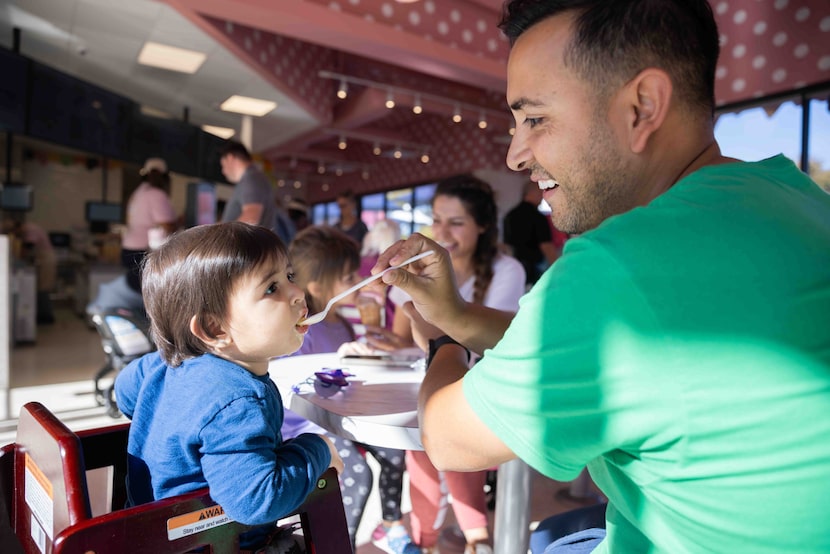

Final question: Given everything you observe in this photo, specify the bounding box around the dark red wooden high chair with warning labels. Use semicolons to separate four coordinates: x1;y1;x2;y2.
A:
0;402;351;554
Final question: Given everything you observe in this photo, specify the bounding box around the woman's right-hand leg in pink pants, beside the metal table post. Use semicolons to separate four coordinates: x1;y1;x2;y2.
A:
444;471;490;545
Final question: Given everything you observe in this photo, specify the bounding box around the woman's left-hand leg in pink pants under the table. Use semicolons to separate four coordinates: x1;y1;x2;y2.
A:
406;451;448;548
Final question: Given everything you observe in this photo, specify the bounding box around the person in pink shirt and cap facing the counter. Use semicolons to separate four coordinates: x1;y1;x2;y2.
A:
121;158;178;292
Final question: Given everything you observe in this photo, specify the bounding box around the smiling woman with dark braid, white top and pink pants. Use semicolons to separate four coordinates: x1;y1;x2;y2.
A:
389;175;525;554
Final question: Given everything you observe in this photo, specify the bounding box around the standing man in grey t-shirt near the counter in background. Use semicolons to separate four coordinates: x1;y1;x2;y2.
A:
219;140;295;245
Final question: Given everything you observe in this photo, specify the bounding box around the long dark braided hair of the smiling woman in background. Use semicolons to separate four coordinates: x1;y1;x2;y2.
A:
432;175;499;304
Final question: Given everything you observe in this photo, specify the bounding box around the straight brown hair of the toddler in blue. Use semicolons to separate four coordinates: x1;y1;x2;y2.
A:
141;221;288;367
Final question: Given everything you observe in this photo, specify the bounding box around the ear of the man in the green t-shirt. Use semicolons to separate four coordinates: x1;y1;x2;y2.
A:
618;67;674;154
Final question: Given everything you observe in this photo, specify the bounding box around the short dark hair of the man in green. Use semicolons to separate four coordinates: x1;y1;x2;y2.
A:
499;0;720;114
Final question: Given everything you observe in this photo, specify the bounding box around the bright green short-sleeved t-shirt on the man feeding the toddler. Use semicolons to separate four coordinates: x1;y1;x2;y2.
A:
464;156;830;554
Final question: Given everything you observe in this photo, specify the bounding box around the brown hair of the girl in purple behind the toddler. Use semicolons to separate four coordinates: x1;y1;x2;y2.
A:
289;225;360;313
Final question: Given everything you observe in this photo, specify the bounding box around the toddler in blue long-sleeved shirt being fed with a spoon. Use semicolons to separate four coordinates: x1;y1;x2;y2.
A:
115;222;346;550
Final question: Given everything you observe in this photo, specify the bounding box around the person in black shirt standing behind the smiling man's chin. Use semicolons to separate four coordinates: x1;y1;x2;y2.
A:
504;181;560;285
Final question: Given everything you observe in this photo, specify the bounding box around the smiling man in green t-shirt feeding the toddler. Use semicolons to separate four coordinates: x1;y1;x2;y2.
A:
376;0;830;553
